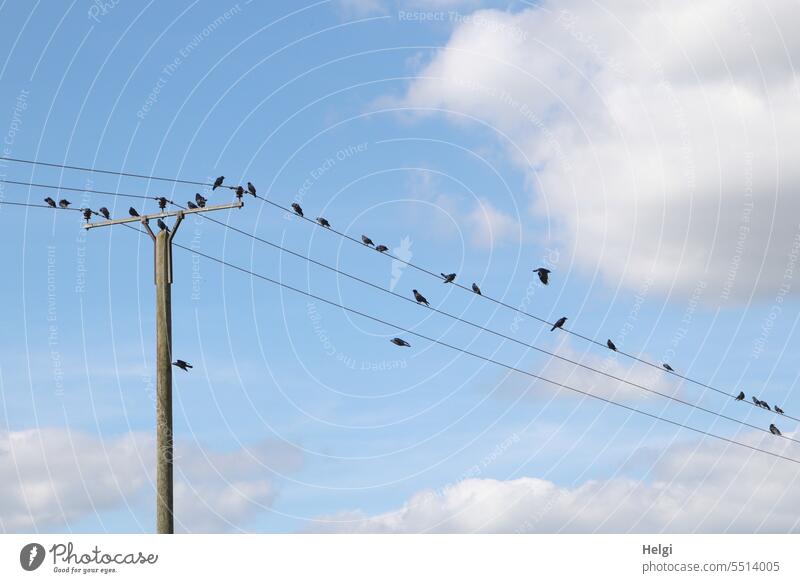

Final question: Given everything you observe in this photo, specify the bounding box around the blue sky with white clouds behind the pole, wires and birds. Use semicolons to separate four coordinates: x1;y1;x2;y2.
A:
0;0;800;533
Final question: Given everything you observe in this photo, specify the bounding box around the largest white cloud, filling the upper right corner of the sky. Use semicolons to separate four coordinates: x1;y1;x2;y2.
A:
403;0;800;300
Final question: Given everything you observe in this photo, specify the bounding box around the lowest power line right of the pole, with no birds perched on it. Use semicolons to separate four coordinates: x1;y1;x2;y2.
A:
173;243;800;464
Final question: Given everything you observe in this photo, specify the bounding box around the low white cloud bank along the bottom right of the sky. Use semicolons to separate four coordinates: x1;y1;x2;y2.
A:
315;436;800;533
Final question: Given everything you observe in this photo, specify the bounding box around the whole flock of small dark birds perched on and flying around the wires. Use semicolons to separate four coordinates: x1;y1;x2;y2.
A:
44;176;785;435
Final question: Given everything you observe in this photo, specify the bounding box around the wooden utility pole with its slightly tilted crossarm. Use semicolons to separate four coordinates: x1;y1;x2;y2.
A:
84;200;244;534
